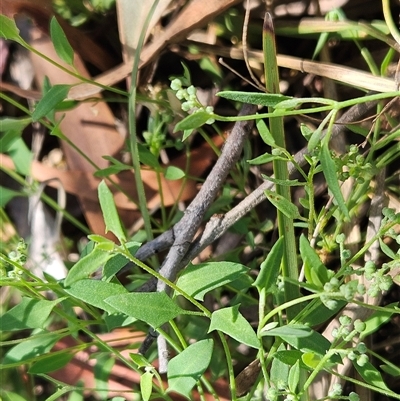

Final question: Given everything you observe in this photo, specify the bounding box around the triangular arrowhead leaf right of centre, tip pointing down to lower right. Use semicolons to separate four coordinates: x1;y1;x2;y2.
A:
208;305;260;349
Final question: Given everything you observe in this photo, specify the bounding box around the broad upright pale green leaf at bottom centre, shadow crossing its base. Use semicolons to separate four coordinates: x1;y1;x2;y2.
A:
168;339;214;399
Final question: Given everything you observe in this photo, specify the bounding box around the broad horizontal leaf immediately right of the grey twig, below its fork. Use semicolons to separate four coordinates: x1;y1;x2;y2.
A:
176;262;248;301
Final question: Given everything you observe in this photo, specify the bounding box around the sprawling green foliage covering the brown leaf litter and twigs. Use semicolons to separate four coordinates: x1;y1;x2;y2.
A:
0;0;400;401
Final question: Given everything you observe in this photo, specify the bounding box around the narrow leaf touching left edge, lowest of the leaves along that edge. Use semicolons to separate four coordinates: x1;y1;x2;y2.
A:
0;332;61;368
